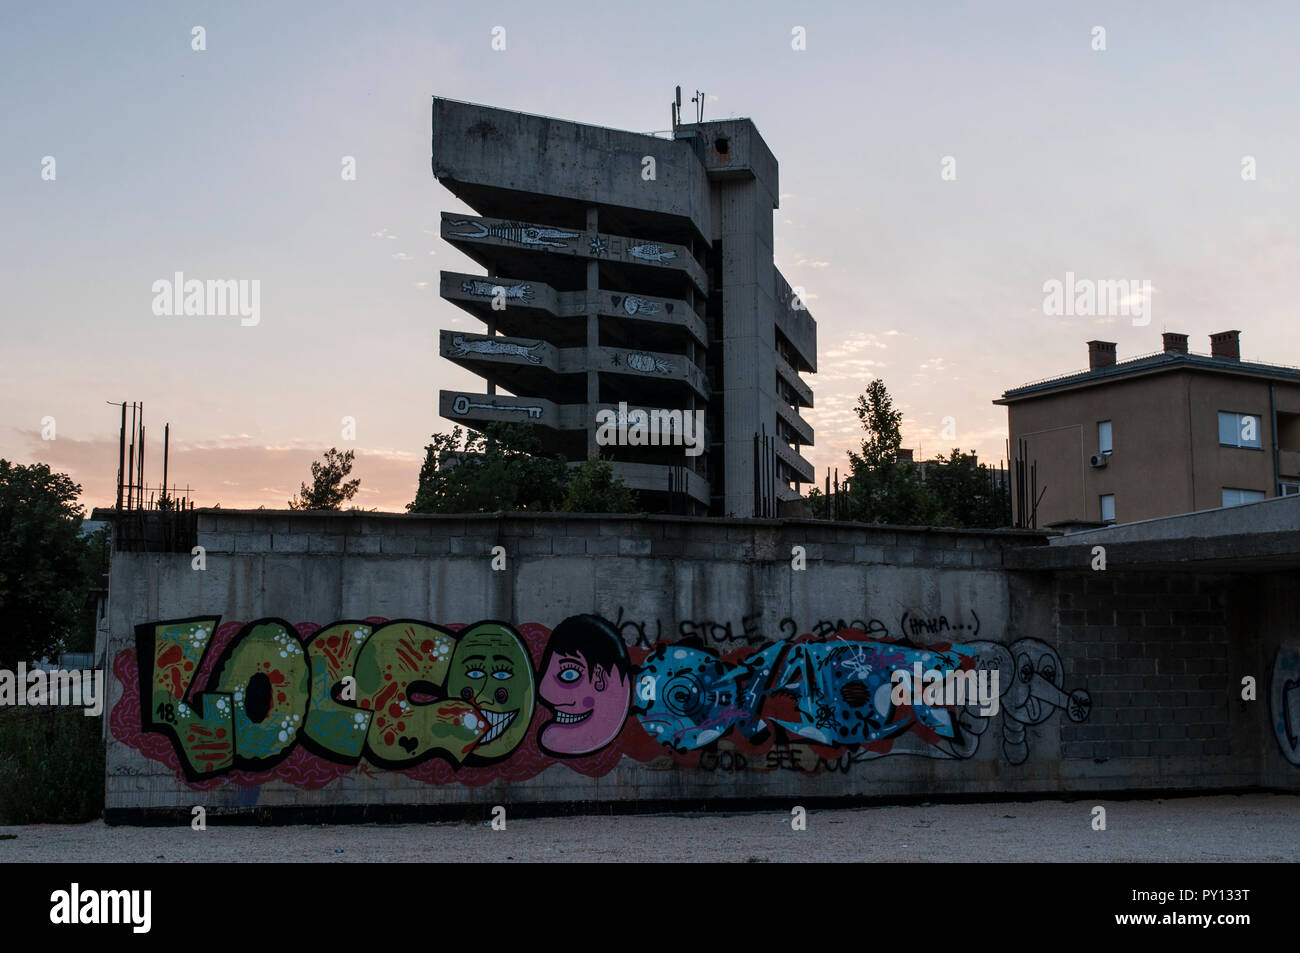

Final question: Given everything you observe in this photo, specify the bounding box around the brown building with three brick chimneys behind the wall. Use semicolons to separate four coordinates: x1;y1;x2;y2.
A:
993;330;1300;527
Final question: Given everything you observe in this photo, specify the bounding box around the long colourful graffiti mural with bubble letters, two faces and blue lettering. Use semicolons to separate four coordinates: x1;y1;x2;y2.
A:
111;611;1091;788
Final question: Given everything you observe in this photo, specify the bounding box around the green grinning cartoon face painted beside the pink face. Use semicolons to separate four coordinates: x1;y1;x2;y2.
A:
447;623;537;759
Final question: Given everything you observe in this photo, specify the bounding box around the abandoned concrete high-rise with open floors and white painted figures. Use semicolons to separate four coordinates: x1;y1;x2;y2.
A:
433;99;816;516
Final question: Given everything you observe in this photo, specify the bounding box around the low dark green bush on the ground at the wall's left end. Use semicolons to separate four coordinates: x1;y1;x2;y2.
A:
0;709;104;824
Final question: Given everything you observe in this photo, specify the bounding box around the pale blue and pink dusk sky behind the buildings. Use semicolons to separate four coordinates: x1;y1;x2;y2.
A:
0;0;1300;511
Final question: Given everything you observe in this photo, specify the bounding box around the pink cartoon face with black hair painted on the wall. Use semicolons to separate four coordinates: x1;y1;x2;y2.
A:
538;616;632;758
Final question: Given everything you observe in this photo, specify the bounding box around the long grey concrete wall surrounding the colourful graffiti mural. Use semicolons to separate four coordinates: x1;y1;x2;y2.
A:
104;511;1300;819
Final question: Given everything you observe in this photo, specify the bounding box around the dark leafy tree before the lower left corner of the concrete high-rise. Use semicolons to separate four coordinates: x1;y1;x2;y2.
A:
407;424;568;512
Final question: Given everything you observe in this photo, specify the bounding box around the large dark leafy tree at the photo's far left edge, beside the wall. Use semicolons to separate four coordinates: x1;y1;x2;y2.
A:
0;460;86;668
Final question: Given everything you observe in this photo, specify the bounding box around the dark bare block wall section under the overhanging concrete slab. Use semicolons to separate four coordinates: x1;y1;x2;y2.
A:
1057;569;1300;788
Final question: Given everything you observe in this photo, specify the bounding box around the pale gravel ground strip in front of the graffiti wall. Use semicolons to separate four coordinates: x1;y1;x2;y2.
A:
0;794;1300;865
